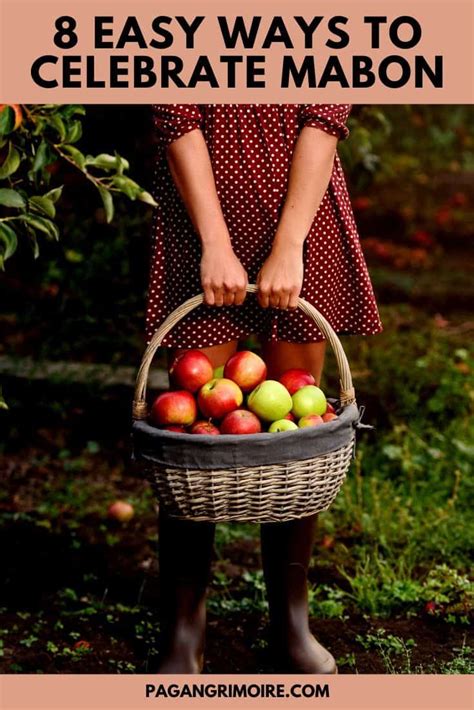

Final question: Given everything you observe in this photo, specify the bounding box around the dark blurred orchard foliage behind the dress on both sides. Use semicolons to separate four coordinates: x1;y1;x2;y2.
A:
0;106;474;362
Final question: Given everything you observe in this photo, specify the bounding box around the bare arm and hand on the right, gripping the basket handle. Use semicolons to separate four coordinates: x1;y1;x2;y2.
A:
257;126;338;309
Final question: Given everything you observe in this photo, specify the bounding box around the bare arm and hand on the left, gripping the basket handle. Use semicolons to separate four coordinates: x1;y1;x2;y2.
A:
167;129;248;306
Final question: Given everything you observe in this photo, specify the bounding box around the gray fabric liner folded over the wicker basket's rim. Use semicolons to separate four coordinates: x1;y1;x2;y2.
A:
132;403;360;470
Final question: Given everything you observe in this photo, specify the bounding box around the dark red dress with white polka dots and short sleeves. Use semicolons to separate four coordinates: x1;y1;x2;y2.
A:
146;104;382;347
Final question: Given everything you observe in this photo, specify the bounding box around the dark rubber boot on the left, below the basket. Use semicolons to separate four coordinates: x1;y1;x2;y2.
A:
157;513;215;673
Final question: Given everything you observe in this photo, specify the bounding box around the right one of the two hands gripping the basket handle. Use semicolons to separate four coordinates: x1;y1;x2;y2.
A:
257;244;303;310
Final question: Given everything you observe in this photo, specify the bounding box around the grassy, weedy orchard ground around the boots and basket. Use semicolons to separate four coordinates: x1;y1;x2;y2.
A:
0;280;473;673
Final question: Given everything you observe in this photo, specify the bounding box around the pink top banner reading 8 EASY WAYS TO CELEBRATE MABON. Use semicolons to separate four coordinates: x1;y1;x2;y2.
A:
0;0;474;104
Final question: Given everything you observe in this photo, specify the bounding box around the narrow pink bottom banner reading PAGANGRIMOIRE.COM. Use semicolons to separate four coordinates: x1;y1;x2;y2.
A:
0;675;473;710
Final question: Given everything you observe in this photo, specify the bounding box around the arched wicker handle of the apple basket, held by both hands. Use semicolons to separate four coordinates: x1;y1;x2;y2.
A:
132;284;355;419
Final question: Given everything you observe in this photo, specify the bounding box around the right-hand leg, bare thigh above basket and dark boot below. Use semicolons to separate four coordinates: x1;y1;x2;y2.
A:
261;342;336;673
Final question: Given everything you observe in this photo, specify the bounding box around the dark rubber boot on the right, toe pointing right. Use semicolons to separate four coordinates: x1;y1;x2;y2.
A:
261;515;337;673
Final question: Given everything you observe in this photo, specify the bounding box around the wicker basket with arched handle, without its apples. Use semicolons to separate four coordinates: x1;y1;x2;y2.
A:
133;285;359;523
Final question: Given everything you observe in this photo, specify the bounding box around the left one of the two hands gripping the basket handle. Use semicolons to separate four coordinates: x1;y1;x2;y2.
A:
201;244;248;306
